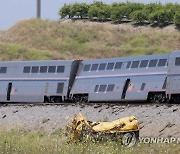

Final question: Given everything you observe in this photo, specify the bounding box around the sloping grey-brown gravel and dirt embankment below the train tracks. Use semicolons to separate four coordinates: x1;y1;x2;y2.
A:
0;104;180;137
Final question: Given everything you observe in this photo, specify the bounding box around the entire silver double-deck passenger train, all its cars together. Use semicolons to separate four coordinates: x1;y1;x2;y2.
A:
0;51;180;103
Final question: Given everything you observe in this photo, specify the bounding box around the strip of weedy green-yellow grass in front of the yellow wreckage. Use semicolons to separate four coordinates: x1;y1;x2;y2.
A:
0;129;180;154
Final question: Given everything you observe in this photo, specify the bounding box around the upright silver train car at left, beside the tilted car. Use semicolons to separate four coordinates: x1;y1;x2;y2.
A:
0;60;79;102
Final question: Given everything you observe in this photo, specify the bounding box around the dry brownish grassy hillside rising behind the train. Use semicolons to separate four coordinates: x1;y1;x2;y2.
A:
0;19;180;59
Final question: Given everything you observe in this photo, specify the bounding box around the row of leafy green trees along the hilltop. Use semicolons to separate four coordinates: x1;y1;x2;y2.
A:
59;1;180;28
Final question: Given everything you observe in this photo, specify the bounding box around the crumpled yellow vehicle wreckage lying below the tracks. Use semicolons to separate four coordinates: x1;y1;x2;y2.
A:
67;113;139;141
